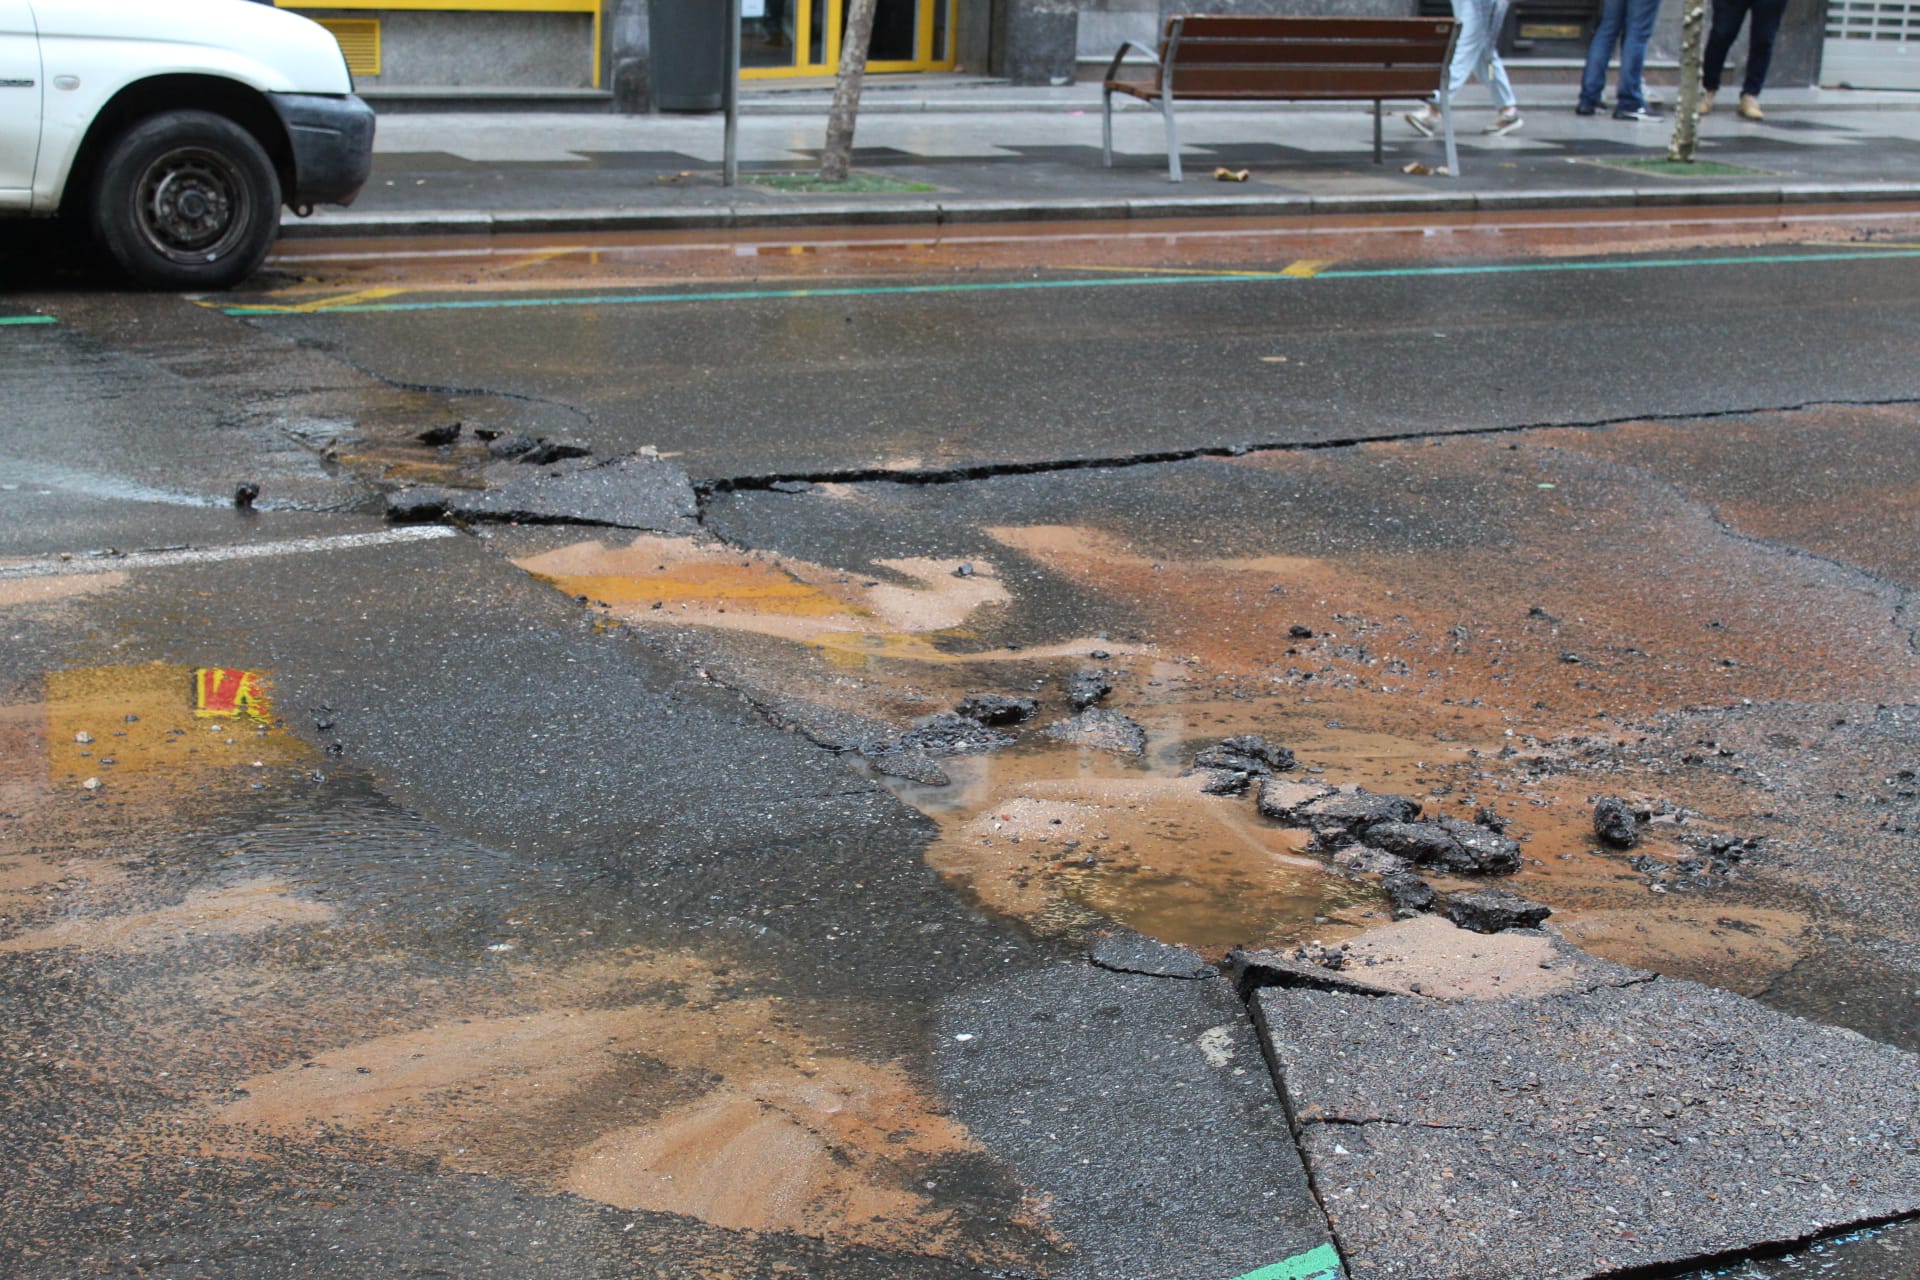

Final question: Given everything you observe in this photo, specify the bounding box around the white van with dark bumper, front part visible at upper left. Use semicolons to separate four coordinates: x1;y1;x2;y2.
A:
0;0;372;288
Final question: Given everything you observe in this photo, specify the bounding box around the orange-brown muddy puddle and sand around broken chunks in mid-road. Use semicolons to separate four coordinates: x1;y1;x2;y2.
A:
518;526;1811;992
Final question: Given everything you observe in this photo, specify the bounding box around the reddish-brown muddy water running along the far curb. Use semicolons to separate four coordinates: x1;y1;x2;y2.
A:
259;205;1920;311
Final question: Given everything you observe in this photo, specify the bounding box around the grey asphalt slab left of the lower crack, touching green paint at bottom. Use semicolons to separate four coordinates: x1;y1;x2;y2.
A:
935;961;1344;1280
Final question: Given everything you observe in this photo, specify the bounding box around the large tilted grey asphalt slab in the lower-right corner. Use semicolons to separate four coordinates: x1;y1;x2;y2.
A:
1254;979;1920;1280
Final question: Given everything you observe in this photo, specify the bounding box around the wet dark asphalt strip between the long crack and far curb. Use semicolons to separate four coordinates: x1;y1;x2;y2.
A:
210;210;1920;478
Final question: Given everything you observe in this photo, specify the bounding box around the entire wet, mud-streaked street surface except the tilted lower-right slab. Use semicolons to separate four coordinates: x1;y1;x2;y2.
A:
0;209;1920;1280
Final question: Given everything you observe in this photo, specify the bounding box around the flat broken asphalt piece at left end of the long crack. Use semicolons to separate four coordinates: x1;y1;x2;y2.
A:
386;453;699;533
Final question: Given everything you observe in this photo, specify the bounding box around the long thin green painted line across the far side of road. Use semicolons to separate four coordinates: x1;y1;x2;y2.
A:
221;249;1920;317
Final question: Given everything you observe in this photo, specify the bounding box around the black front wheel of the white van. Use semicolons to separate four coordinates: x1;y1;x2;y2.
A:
92;111;280;290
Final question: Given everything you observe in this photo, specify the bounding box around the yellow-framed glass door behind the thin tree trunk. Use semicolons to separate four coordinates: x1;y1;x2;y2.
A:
739;0;954;79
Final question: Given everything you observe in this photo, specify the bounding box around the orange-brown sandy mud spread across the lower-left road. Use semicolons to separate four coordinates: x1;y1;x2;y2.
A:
0;664;1056;1278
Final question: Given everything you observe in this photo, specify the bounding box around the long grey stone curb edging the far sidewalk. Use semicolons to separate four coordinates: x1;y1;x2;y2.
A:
280;182;1920;240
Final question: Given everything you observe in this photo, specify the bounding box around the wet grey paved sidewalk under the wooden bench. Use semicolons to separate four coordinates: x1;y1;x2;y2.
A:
282;77;1920;236
